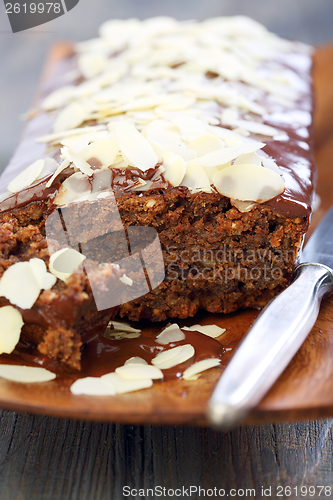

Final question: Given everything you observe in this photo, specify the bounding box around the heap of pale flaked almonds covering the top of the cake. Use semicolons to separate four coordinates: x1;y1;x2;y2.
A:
35;16;311;202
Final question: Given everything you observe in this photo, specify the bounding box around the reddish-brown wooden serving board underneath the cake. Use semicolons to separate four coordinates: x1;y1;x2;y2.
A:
0;44;333;425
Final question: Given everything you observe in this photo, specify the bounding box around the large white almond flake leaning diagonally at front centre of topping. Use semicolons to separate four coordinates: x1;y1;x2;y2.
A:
116;123;158;172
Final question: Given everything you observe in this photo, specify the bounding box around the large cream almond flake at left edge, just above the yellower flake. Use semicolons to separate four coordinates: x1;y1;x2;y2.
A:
0;262;41;309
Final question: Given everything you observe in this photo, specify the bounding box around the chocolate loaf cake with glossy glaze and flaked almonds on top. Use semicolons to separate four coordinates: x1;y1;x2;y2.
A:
0;17;314;369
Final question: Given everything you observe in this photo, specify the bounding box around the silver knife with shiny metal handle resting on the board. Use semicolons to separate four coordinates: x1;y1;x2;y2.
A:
207;207;333;430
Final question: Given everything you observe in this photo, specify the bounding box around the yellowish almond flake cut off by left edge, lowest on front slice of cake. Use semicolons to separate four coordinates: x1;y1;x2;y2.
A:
0;306;24;356
